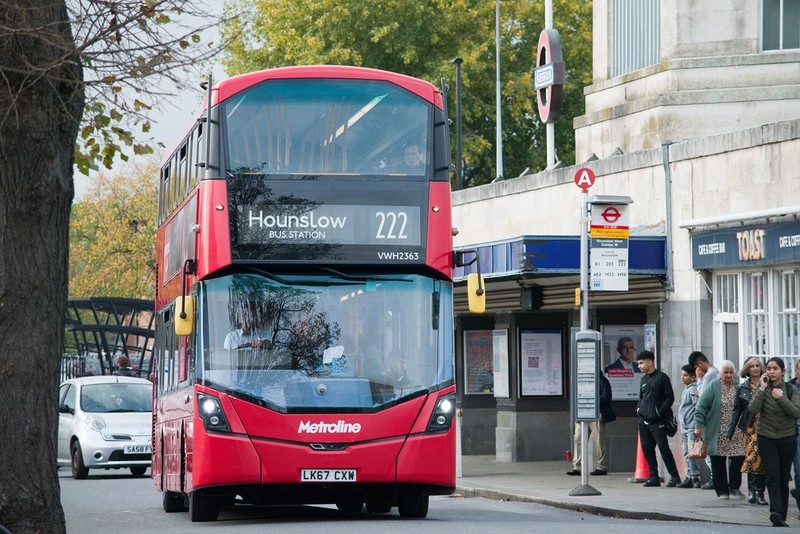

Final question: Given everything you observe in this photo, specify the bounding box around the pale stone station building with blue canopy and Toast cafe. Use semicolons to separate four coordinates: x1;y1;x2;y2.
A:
453;0;800;471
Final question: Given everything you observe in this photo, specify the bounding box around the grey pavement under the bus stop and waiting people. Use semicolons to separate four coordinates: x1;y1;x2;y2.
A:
456;455;800;529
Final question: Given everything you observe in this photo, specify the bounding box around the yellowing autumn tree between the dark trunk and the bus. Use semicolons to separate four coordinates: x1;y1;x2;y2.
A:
69;159;159;299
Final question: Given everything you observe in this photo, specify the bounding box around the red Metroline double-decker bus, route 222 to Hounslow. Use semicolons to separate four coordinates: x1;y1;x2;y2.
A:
152;66;484;521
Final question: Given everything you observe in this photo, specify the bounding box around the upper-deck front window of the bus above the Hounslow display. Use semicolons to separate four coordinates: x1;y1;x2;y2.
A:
223;80;432;176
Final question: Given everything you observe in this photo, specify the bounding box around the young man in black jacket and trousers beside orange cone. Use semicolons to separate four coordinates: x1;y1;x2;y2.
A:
636;350;681;488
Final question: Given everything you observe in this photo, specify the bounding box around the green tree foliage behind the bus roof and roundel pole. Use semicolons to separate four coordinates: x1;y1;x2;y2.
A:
223;0;592;185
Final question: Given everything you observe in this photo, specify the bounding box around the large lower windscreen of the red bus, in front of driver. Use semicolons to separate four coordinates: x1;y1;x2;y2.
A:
198;272;453;412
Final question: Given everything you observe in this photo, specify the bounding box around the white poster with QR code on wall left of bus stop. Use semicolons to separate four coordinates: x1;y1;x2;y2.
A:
520;330;564;396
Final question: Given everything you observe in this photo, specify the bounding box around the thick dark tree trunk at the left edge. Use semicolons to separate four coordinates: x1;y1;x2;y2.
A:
0;0;84;534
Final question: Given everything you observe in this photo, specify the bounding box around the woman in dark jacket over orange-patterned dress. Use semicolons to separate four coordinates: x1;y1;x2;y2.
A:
727;356;767;505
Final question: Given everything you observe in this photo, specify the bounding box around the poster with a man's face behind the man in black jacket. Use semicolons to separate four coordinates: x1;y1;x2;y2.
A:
602;324;658;401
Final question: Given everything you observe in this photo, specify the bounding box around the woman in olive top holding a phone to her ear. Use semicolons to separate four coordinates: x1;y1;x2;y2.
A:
747;356;800;527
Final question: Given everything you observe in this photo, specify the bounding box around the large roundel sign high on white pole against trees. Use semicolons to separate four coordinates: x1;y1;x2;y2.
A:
533;28;564;123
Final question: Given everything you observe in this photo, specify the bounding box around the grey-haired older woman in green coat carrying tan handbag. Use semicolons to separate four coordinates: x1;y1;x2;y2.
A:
694;360;744;499
